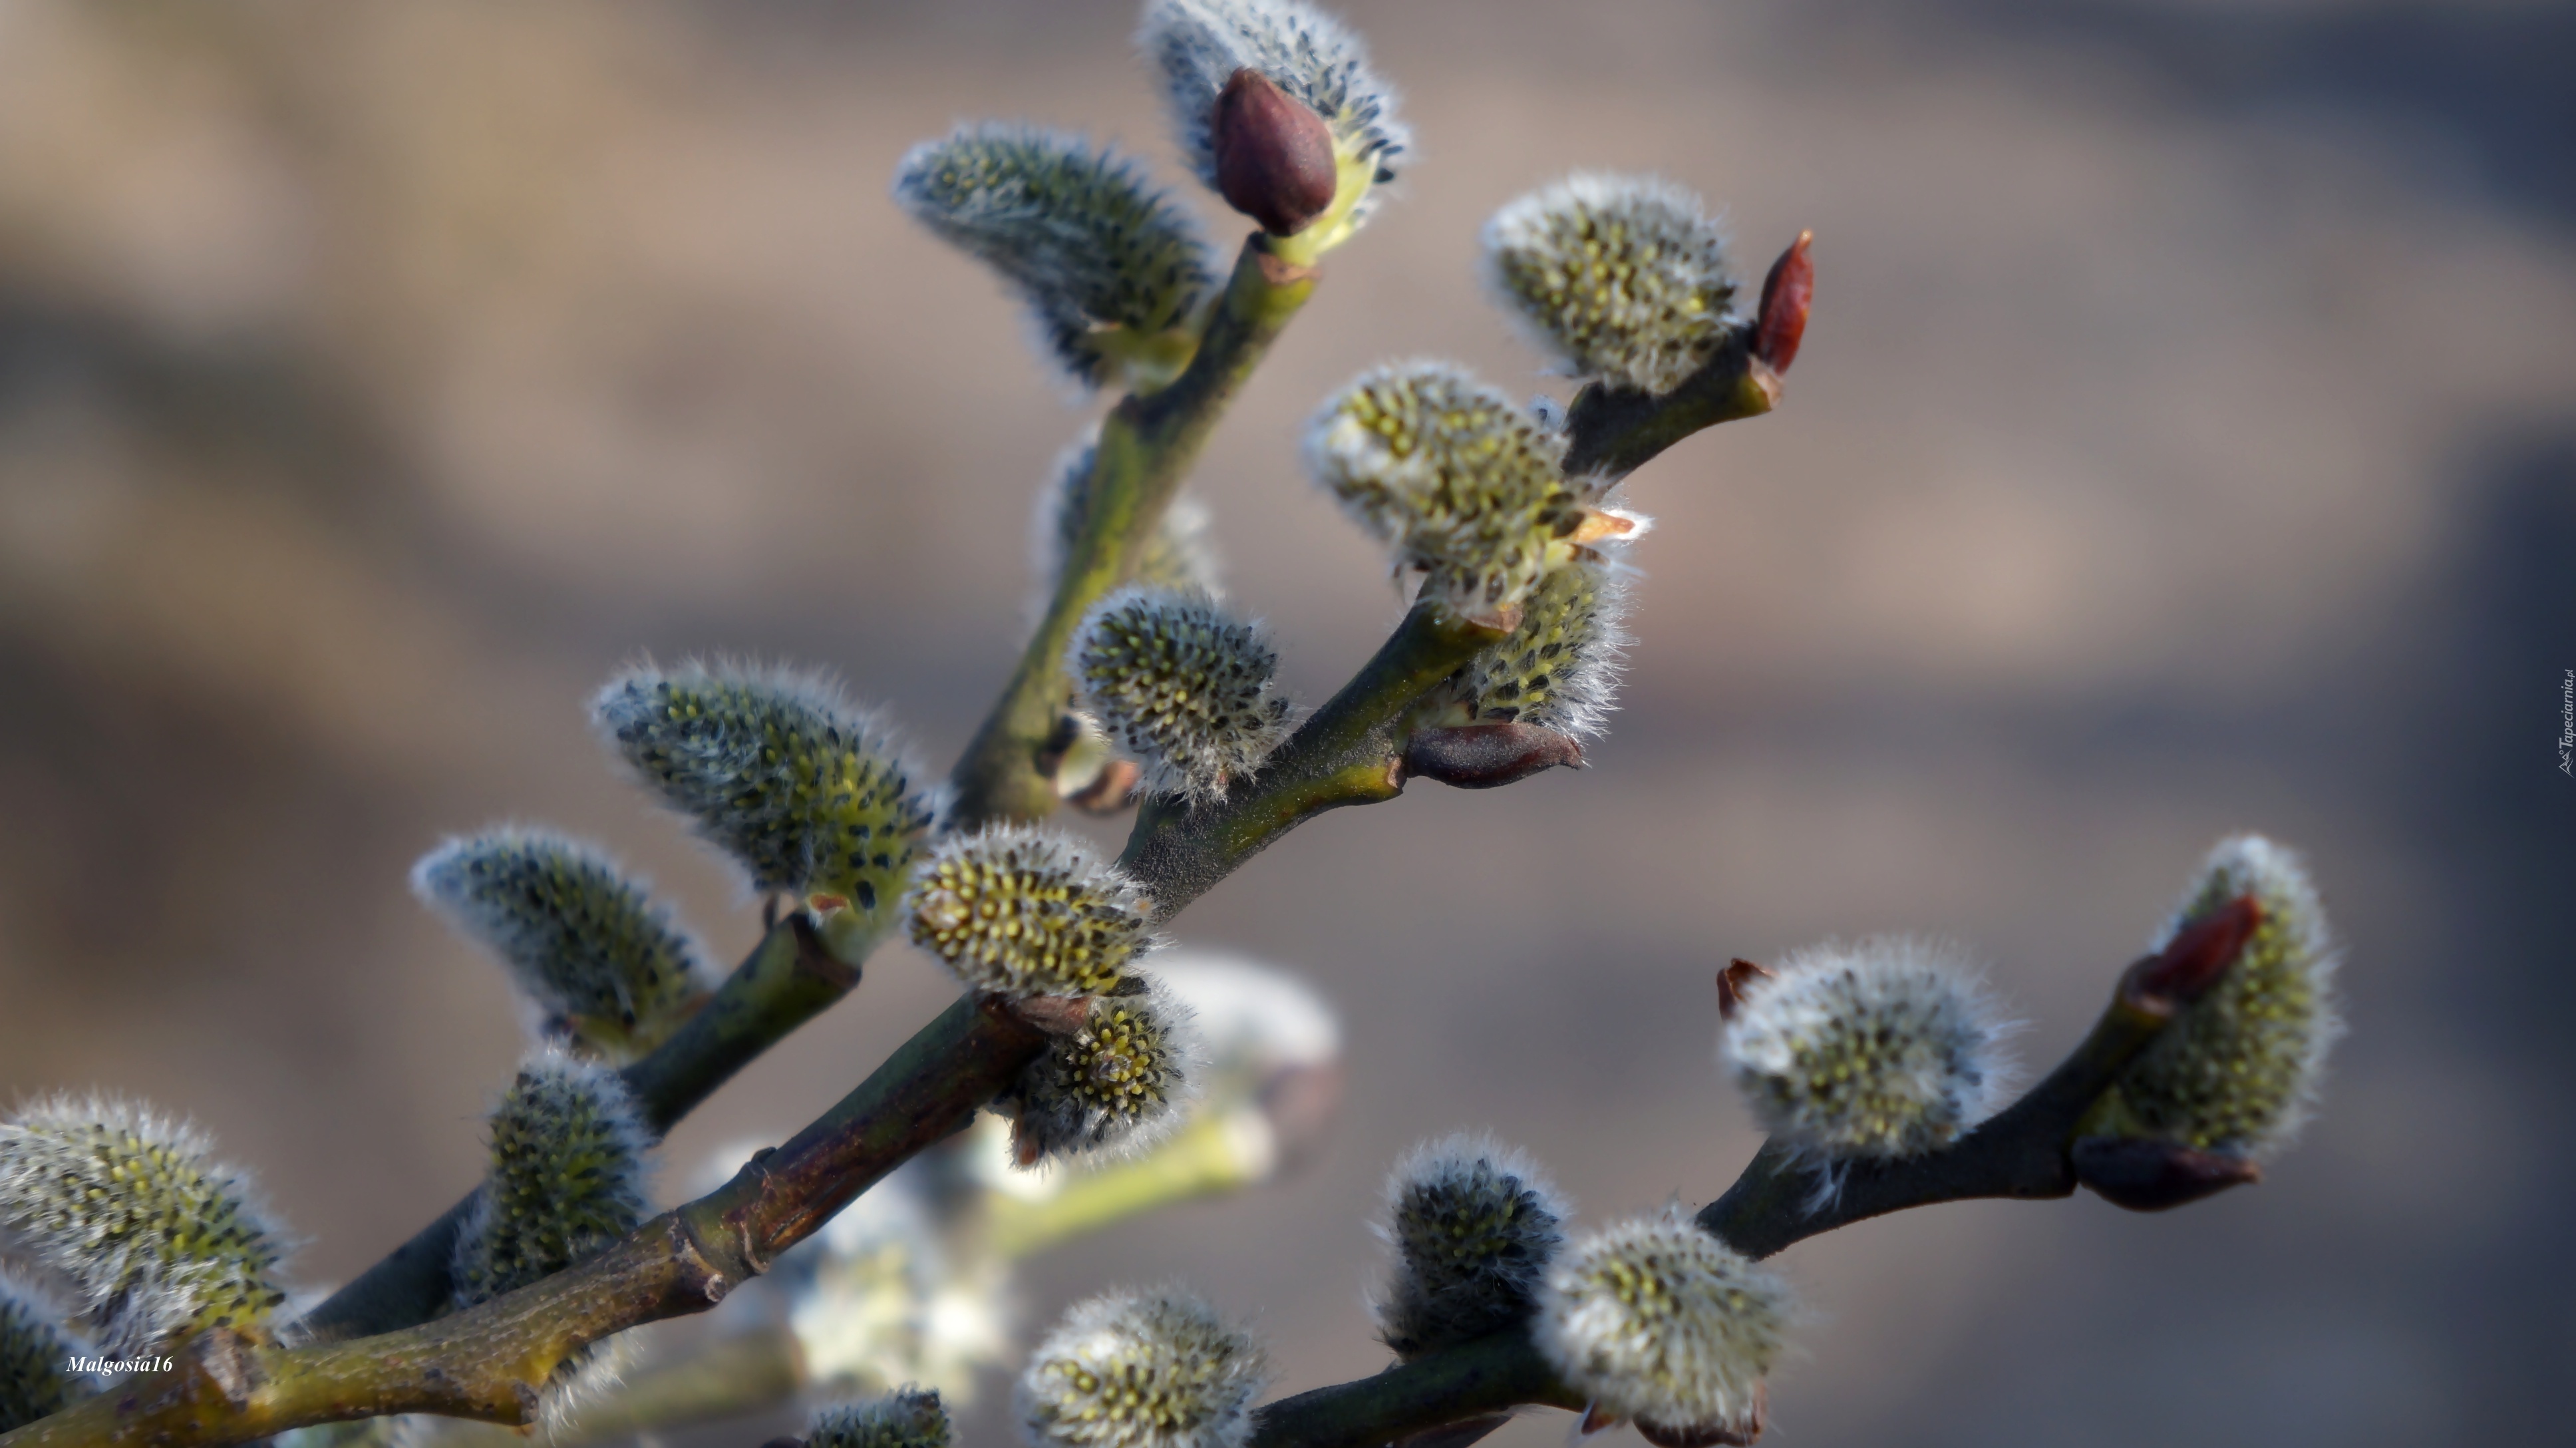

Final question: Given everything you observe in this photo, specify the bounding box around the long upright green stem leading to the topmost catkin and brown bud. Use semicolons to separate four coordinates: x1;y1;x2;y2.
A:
948;234;1317;827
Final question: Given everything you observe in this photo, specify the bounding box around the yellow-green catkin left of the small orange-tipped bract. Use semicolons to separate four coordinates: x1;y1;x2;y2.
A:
1306;361;1592;616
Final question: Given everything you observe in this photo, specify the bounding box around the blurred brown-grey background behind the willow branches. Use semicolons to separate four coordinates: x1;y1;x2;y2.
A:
0;0;2576;1448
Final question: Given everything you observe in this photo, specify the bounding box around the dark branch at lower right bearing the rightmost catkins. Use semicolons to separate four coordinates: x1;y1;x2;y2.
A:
1231;917;2249;1448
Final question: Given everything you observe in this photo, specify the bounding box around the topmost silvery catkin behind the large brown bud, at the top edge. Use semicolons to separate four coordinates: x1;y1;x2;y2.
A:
1136;0;1409;203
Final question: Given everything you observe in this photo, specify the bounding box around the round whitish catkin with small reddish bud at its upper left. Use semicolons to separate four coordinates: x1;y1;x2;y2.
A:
1718;935;2004;1162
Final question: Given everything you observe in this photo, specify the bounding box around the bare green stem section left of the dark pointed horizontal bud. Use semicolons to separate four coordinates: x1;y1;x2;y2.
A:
1118;603;1507;920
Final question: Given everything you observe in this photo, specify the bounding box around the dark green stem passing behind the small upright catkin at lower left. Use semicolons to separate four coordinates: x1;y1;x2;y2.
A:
296;915;858;1340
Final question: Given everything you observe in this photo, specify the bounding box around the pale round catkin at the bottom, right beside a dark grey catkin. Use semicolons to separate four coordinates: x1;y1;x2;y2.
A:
1533;1211;1793;1435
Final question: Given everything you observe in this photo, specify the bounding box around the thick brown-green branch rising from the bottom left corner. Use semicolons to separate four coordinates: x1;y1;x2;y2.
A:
0;997;1046;1448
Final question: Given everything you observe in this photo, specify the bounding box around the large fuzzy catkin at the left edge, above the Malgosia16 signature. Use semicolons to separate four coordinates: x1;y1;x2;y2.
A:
0;1097;286;1358
